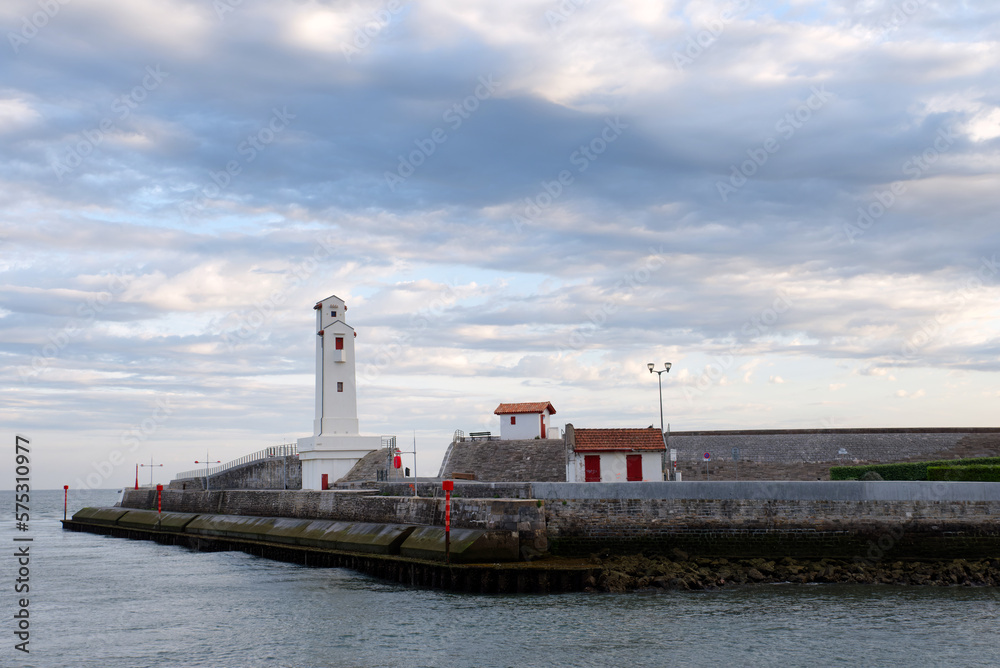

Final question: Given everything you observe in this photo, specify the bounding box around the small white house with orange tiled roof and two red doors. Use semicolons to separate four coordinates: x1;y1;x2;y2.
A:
566;424;666;482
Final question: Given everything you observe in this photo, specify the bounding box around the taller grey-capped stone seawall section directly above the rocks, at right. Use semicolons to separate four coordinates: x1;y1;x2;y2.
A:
532;482;1000;561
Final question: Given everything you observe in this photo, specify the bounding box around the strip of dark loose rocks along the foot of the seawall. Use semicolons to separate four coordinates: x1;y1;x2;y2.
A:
587;550;1000;592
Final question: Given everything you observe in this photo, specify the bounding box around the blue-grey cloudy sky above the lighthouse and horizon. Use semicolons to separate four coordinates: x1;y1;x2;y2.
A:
0;0;1000;488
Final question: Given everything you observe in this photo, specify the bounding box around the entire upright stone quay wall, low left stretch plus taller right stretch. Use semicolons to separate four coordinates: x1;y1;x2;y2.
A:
122;481;1000;561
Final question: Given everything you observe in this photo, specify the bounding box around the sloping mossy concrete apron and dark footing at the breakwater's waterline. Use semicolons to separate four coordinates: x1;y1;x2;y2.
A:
63;507;599;594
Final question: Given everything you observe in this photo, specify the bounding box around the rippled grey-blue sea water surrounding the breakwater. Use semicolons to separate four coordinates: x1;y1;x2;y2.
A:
0;490;1000;668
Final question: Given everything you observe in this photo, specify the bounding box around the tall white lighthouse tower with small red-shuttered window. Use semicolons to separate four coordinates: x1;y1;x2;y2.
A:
298;295;381;489
